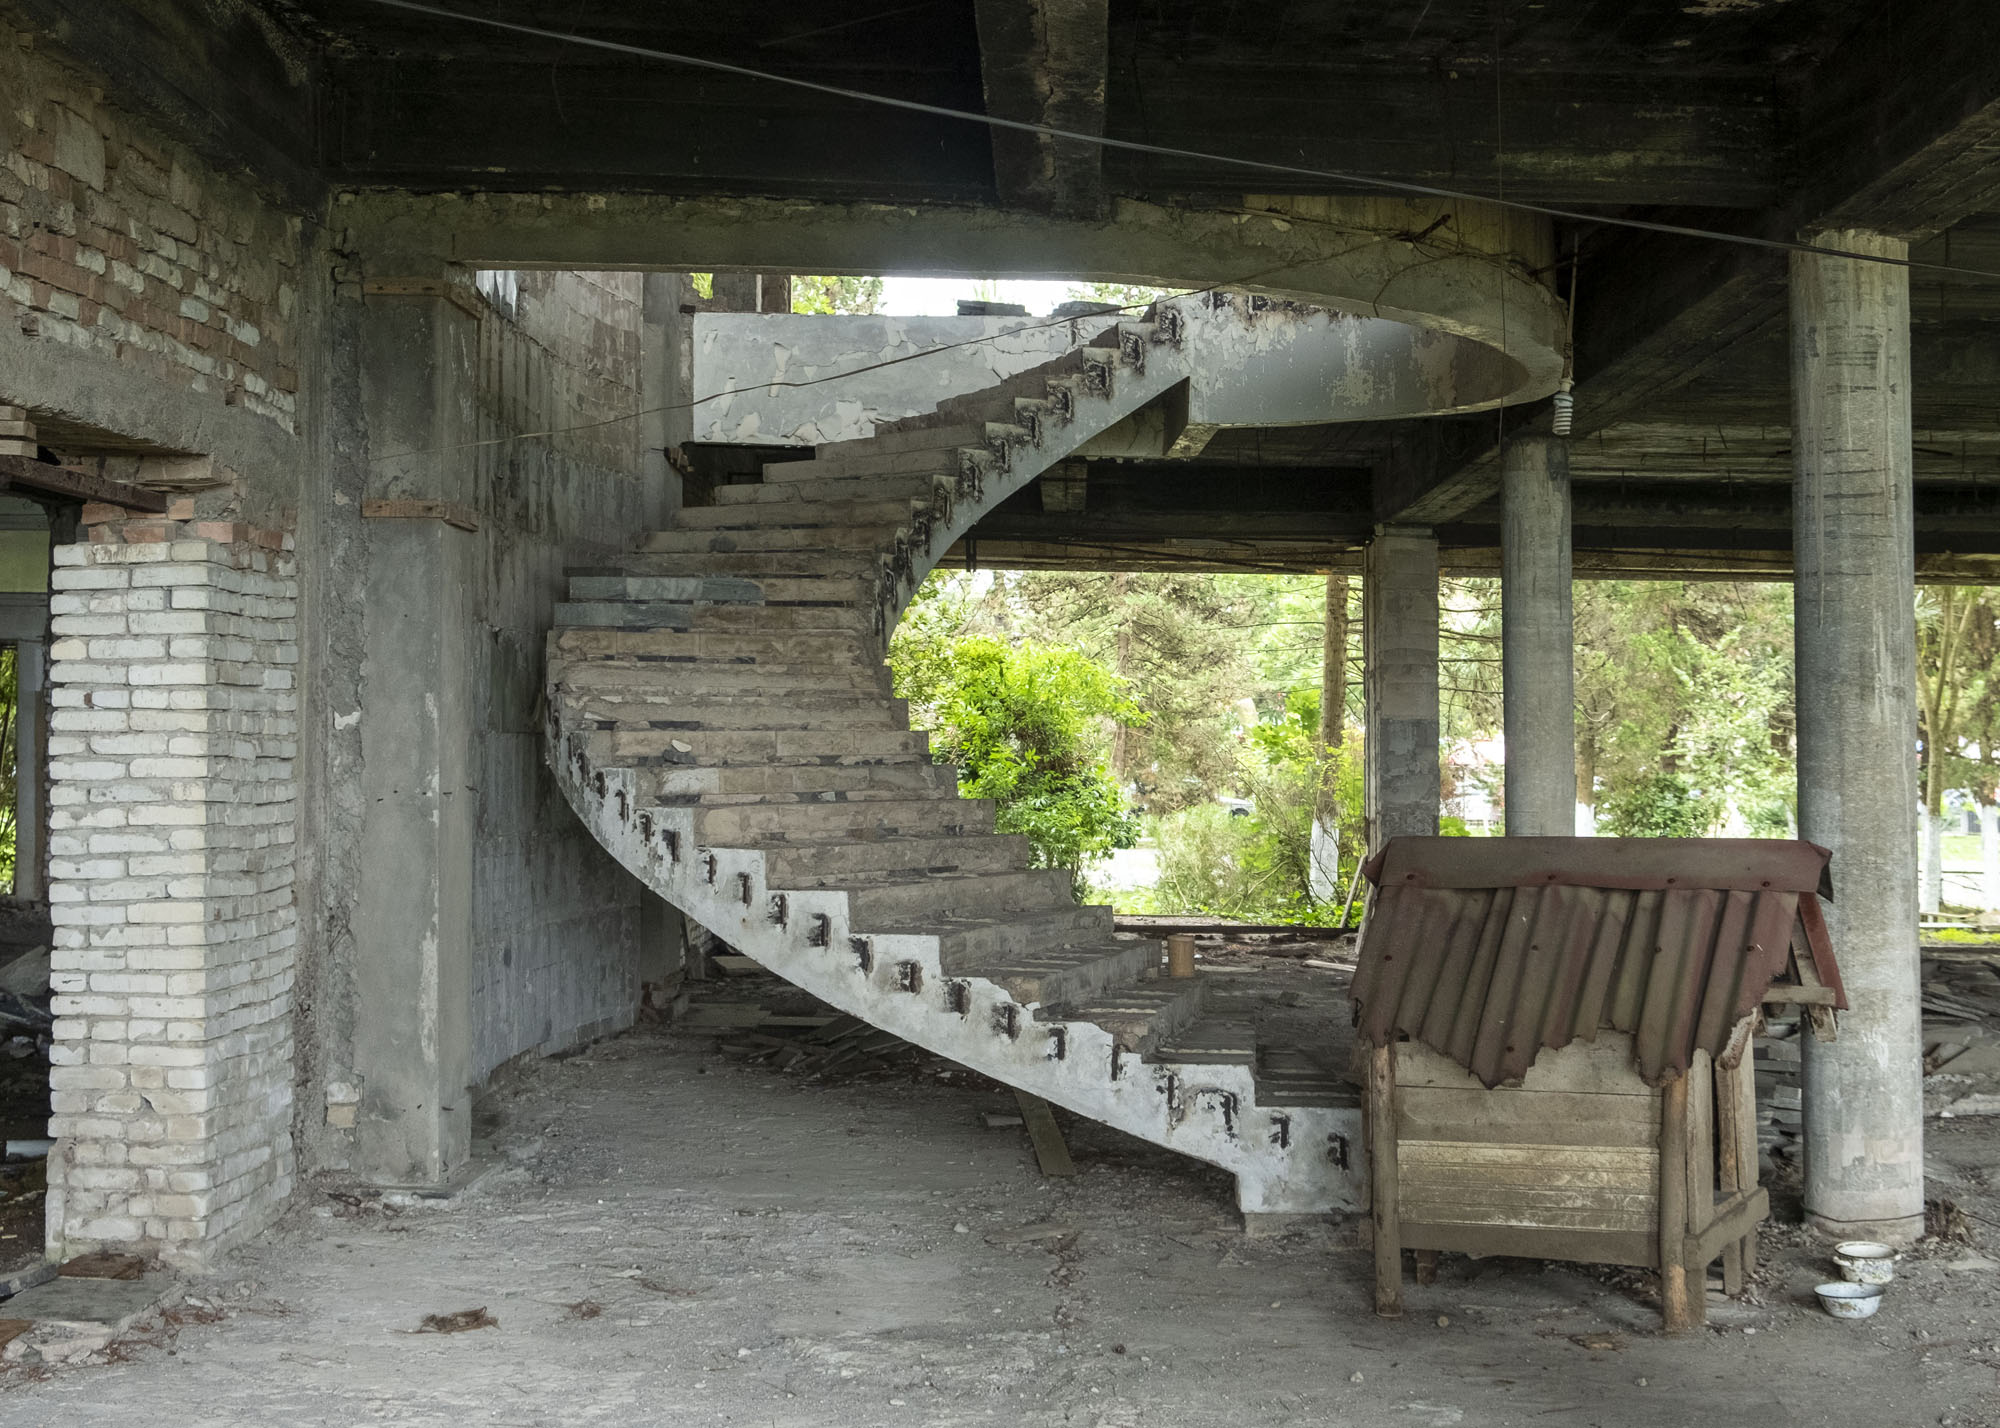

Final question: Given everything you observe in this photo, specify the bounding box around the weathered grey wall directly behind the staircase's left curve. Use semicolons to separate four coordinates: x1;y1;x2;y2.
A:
458;272;656;1078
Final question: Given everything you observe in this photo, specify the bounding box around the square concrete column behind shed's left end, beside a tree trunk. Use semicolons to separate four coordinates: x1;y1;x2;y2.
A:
1362;526;1438;850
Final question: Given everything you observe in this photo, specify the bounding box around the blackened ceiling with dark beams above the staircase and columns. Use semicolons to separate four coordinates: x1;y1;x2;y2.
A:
14;0;2000;572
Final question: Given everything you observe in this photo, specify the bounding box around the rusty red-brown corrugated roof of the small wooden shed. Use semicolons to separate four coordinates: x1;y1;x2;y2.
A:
1352;838;1846;1086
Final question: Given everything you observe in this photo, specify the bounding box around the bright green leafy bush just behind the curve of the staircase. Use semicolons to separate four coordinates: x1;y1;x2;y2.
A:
888;584;1146;892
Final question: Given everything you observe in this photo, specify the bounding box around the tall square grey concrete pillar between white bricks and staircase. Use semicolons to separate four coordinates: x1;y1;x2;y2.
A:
354;272;478;1184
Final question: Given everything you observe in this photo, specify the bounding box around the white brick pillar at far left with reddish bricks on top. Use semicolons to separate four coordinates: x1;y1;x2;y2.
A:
48;520;298;1266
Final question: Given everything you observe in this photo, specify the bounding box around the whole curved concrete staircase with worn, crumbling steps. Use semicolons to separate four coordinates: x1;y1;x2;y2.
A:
548;304;1366;1214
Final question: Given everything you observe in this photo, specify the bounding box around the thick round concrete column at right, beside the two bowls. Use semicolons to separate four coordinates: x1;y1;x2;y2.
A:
1792;232;1924;1242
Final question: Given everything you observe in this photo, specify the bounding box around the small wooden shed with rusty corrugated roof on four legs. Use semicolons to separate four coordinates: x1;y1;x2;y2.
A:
1354;838;1846;1332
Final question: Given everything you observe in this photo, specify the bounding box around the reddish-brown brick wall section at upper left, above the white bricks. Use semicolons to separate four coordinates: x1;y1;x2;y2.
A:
0;24;302;432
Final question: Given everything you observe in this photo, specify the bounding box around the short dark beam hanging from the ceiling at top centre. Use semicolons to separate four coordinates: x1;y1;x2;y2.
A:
974;0;1110;218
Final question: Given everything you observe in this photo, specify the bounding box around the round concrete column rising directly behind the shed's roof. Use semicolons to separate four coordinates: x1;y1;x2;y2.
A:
1500;436;1576;838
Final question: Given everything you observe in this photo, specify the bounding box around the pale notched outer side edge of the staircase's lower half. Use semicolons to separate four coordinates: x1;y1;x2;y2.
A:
560;758;1366;1214
